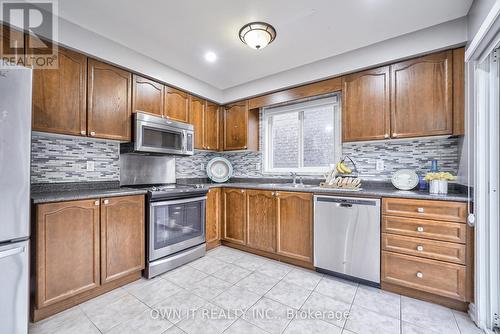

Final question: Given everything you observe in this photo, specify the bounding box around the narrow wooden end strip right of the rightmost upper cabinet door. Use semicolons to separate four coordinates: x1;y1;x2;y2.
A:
453;48;465;136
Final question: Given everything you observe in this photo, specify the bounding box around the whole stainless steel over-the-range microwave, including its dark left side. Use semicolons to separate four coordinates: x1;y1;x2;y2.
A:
120;112;194;155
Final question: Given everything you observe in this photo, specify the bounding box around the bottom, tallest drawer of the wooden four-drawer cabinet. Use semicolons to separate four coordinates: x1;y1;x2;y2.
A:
382;251;465;301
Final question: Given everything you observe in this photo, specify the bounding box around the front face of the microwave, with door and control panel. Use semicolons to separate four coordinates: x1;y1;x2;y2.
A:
134;120;194;155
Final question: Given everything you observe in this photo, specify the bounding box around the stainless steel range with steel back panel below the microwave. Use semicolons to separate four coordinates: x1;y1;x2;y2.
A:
120;154;208;278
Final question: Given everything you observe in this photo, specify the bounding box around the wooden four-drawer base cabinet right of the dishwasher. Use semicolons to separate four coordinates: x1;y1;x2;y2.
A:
381;198;474;310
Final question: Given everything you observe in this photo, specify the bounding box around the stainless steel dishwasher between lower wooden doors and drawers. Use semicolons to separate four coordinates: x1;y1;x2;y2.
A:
314;195;380;286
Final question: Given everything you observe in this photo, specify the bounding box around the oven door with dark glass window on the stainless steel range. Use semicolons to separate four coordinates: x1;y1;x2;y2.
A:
149;196;207;261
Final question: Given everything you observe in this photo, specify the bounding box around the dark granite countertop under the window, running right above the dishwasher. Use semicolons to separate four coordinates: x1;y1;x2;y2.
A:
177;178;469;202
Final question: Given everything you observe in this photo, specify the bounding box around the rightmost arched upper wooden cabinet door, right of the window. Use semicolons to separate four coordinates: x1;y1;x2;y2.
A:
391;51;453;138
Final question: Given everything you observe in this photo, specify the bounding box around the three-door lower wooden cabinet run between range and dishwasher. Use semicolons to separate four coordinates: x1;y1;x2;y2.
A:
222;189;313;266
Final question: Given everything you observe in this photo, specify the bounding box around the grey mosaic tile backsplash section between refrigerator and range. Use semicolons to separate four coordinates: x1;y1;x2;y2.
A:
31;133;120;183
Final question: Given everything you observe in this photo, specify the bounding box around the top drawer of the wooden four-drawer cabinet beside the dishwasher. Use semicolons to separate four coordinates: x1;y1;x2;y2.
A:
382;198;467;223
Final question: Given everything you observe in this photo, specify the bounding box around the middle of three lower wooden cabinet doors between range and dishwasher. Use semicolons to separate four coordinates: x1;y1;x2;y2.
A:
247;190;276;253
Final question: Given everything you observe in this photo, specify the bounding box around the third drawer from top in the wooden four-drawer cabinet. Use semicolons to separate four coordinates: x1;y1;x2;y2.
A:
382;233;465;264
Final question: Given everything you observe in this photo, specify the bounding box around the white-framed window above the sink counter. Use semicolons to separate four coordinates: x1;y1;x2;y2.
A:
263;94;341;174
